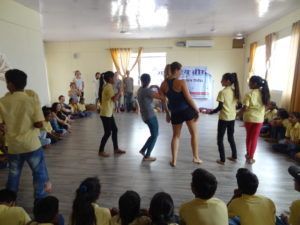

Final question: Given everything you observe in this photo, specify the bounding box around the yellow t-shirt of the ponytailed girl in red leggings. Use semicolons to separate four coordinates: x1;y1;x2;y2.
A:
243;89;265;123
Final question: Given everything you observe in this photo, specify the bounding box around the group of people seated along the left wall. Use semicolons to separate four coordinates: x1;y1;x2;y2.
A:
39;95;91;148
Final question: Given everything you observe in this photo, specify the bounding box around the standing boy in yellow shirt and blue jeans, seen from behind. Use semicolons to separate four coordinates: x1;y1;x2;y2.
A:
0;69;51;199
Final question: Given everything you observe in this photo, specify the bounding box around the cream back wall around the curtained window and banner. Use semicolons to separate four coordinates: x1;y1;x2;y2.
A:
45;37;245;107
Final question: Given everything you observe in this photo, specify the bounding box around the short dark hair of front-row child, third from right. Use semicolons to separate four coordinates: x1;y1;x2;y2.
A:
192;168;218;199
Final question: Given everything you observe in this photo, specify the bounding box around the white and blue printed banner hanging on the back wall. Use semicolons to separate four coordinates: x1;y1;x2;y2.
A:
180;66;213;99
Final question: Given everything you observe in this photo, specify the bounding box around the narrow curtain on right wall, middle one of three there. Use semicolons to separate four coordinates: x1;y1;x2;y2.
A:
265;33;276;82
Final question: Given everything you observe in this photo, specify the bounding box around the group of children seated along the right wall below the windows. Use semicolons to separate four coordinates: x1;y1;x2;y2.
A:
261;102;300;160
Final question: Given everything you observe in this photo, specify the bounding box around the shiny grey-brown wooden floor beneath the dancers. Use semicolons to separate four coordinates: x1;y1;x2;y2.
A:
0;113;299;218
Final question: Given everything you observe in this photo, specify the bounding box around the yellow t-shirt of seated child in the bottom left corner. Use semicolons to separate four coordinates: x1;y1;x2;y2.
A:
0;205;31;225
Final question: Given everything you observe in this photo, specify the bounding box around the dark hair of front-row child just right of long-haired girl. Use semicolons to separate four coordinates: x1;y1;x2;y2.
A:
119;191;141;225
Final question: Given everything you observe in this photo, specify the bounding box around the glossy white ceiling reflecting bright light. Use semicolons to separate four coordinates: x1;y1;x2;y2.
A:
16;0;300;41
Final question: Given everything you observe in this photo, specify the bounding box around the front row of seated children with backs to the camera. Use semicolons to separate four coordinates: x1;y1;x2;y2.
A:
0;166;300;225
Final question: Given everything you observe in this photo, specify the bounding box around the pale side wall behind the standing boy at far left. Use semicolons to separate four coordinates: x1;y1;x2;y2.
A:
0;0;50;104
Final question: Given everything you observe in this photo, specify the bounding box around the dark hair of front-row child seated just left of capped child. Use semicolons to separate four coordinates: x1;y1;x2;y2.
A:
236;168;259;195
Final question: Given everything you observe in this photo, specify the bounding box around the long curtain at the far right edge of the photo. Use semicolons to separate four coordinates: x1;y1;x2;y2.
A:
289;20;300;112
